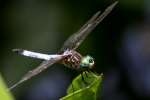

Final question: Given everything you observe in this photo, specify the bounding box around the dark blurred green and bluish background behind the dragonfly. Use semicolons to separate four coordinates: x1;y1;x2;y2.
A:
0;0;150;100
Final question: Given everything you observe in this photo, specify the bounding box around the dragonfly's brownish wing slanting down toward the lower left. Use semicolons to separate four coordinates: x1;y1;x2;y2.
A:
9;55;68;90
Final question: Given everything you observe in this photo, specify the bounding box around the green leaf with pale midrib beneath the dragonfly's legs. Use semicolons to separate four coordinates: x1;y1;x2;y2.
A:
60;72;102;100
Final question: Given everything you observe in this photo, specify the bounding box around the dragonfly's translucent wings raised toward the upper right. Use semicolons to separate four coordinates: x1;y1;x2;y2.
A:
60;1;118;52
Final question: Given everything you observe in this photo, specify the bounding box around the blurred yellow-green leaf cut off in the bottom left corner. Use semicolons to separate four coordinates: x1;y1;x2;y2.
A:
0;75;14;100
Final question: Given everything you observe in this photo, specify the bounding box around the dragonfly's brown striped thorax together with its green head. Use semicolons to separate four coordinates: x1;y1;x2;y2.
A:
62;50;94;70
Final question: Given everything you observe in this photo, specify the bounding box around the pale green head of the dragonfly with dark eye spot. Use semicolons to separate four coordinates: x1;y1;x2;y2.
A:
80;55;94;69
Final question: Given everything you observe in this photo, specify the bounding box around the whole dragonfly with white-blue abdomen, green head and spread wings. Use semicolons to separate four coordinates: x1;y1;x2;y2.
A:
9;1;118;90
